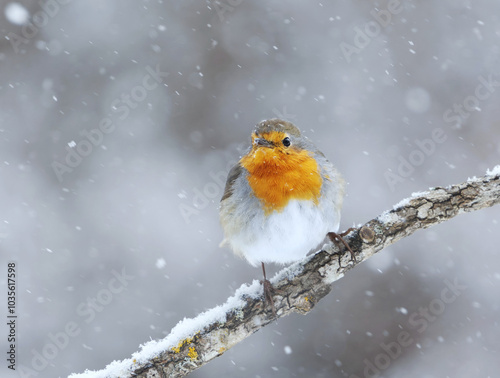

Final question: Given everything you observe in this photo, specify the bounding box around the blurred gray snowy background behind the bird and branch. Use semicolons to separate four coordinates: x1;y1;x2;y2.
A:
0;0;500;377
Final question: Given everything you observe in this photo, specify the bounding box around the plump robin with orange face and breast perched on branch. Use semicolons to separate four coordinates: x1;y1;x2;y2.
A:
220;119;354;315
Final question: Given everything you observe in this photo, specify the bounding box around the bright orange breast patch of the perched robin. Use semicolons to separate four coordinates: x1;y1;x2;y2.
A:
240;148;322;214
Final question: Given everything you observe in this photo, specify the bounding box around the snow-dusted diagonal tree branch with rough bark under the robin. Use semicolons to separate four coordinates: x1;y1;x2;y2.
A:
71;166;500;378
